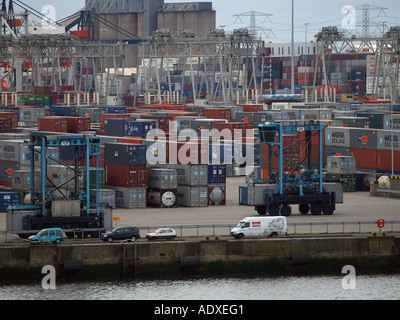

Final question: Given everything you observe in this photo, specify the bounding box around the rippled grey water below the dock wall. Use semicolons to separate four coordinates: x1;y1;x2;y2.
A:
0;274;400;301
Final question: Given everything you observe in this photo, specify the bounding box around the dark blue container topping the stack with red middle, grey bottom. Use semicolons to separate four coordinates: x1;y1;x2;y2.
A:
104;143;146;166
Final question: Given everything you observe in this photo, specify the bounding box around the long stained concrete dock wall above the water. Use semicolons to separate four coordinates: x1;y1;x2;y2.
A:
0;236;400;281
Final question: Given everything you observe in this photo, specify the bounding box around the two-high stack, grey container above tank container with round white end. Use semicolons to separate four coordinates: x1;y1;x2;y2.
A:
148;169;178;208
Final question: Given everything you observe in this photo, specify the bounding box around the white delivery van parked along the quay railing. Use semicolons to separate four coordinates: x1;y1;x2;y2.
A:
231;217;287;239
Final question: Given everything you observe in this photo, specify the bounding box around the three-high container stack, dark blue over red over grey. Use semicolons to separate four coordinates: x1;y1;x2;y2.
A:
104;143;148;209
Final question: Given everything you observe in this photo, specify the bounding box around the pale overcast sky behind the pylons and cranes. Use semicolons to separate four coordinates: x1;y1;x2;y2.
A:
14;0;400;43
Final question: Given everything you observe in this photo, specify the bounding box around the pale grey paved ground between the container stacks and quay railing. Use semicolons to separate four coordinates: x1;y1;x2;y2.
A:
0;177;400;241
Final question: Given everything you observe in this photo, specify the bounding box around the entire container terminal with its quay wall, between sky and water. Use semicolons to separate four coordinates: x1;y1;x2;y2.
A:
0;0;400;281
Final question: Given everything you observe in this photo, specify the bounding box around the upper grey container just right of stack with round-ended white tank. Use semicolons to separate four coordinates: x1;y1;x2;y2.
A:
167;164;208;187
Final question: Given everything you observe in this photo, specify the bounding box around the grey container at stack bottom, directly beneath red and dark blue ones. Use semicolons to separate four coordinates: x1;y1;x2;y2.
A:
106;185;147;209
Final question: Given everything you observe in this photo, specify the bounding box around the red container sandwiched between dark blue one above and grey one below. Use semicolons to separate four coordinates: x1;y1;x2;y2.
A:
104;164;149;187
